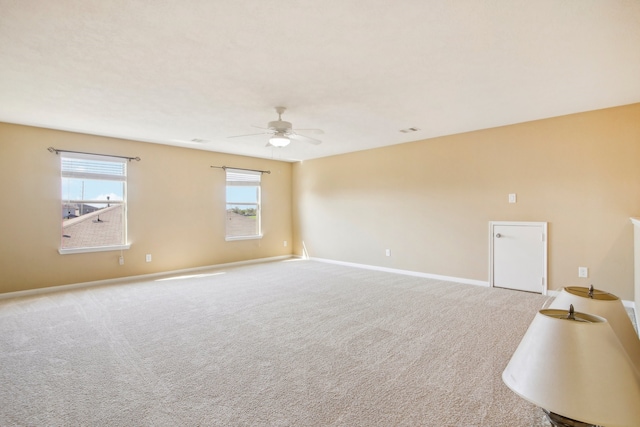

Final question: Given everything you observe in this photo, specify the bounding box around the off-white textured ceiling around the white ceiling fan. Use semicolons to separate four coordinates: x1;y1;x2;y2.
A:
0;0;640;161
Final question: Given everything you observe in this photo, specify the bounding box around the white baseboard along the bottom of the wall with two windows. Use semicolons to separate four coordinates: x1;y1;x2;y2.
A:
0;255;293;300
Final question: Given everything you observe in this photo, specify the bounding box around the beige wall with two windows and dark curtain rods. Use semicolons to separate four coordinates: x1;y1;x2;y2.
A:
0;123;292;293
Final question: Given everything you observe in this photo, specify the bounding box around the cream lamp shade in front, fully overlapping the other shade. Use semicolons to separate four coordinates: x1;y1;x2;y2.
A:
502;309;640;427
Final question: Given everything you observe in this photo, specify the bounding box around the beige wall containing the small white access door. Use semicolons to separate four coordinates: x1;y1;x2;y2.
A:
293;104;640;300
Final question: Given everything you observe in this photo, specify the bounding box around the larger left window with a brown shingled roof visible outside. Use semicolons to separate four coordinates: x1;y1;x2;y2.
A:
60;154;129;254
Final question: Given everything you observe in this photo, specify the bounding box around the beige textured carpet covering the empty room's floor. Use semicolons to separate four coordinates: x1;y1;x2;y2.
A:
0;260;548;427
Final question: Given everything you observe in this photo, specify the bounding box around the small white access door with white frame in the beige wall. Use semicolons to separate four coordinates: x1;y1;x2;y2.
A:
489;221;547;295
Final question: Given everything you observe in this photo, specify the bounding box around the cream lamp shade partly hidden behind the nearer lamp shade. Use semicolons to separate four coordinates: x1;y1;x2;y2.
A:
549;286;640;374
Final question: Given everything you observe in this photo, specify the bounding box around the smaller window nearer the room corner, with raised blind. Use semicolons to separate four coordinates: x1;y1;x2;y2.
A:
226;169;262;240
